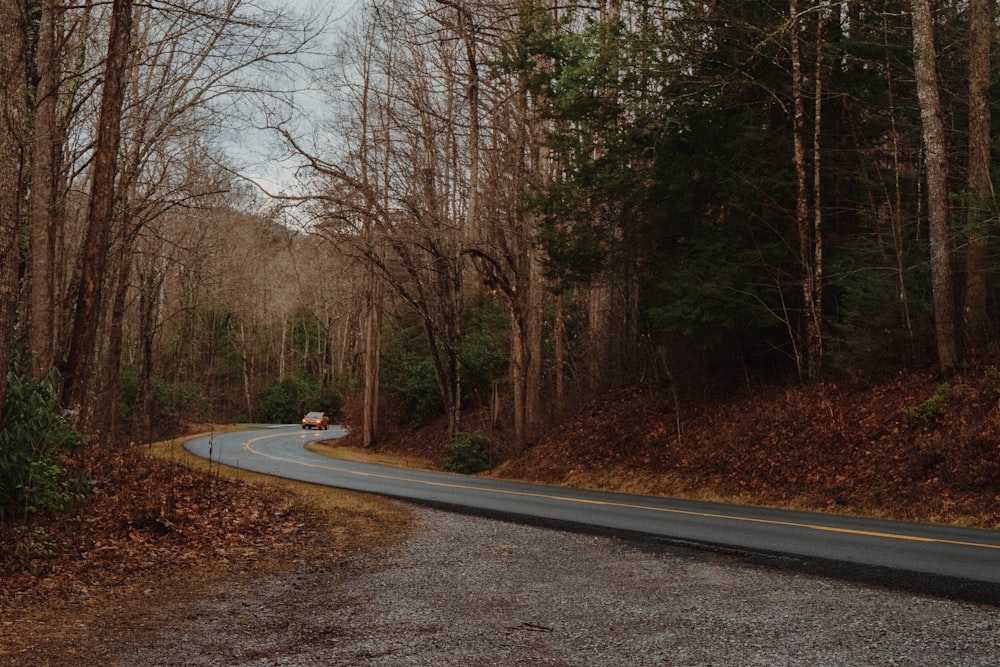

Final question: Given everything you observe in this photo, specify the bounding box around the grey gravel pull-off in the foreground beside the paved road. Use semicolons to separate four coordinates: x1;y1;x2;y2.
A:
27;506;1000;667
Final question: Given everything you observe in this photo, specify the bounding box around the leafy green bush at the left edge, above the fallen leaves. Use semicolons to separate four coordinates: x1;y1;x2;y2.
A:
0;367;83;518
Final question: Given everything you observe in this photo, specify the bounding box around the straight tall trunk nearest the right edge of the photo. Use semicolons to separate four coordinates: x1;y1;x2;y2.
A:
964;0;994;360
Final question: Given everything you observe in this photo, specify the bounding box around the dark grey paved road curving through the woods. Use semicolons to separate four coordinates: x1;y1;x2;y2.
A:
185;425;1000;604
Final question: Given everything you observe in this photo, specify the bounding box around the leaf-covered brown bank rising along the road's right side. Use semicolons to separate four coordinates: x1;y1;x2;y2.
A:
360;369;1000;528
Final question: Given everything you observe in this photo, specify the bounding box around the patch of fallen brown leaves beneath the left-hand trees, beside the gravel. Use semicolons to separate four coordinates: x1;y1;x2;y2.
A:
0;446;307;606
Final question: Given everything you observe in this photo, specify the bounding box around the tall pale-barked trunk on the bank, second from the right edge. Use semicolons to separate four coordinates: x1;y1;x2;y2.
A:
913;0;958;376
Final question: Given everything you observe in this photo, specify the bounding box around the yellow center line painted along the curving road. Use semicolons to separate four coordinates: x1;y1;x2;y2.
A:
243;434;1000;550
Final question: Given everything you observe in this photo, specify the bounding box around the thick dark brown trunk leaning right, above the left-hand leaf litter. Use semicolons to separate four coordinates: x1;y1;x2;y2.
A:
62;0;132;409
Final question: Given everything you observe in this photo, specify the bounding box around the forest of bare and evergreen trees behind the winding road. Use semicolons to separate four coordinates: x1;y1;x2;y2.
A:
0;0;1000;516
